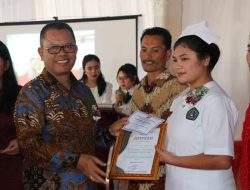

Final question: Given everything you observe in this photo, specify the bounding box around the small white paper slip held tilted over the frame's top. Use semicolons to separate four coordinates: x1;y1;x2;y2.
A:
123;111;164;134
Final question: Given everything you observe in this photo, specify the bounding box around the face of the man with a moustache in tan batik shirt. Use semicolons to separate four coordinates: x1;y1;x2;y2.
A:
140;35;171;77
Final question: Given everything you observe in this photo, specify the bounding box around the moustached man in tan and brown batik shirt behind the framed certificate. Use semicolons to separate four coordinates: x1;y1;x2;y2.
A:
128;27;186;190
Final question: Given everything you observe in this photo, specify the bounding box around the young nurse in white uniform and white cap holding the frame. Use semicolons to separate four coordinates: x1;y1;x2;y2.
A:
157;22;238;190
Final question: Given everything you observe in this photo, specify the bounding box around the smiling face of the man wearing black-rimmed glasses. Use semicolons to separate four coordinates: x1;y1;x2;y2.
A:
38;29;77;79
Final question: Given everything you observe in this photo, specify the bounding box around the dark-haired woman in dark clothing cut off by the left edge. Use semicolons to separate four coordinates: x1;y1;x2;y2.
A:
0;41;23;190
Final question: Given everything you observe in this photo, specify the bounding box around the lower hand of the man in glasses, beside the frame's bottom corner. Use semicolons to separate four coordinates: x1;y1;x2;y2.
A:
77;154;106;184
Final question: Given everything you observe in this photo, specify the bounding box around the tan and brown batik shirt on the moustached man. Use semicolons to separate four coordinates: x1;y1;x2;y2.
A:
131;69;186;119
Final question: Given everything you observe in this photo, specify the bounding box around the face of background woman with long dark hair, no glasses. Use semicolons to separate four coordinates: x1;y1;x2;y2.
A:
84;59;101;82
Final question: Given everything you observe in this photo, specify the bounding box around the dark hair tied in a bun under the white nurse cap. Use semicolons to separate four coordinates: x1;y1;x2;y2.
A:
174;35;220;72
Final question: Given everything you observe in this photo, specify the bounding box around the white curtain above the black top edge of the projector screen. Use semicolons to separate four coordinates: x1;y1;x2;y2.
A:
0;0;155;28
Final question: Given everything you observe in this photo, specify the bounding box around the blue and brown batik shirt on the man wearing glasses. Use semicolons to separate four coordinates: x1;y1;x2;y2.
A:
14;70;113;190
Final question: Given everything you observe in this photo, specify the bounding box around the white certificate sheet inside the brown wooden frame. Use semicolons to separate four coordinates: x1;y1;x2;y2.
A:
116;128;160;174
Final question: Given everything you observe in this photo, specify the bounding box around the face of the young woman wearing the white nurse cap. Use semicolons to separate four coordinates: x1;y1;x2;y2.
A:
173;44;212;89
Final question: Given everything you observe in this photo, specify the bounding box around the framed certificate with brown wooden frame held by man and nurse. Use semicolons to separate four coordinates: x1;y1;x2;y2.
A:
109;123;167;180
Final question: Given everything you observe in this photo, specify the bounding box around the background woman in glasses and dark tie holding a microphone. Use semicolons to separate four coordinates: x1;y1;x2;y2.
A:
115;63;139;115
